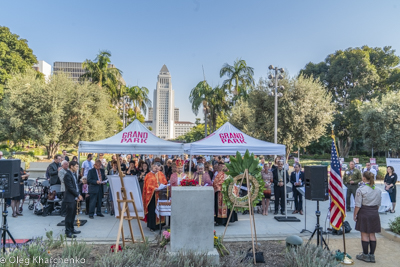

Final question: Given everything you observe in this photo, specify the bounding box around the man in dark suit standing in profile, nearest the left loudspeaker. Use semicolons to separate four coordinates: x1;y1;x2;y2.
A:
63;161;83;238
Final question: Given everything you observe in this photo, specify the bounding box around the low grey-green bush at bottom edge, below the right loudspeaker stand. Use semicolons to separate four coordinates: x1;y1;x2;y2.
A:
285;245;339;267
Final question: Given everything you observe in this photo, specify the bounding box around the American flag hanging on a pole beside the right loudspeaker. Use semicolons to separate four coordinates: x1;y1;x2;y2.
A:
329;139;346;230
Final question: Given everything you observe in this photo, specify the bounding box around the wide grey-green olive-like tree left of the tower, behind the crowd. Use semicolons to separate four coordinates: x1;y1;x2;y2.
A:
0;70;118;158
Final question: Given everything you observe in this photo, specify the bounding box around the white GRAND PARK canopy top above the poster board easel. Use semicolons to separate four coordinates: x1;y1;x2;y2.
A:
79;119;183;155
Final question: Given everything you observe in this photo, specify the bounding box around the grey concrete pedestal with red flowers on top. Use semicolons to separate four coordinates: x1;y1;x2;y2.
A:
169;186;219;263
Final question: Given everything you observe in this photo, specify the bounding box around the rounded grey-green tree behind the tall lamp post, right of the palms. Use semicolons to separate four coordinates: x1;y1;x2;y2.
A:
229;76;334;159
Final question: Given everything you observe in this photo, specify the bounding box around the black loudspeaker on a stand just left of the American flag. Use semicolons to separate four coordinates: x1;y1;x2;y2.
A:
304;165;329;201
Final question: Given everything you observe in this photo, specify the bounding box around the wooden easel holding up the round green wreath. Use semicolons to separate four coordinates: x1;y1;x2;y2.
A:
221;169;257;264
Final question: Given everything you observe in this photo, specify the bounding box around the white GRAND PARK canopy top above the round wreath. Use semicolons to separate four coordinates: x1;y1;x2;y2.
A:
185;122;286;155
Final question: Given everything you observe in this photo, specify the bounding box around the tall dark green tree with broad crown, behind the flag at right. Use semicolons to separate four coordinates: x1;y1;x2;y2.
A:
301;46;400;157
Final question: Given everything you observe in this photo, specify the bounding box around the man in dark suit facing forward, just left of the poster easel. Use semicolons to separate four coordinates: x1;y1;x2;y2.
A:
87;160;106;219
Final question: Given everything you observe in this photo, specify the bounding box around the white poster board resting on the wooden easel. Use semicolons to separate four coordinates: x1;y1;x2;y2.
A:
107;175;144;218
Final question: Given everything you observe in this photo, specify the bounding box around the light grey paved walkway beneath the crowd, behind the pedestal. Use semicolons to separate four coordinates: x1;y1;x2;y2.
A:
7;185;400;242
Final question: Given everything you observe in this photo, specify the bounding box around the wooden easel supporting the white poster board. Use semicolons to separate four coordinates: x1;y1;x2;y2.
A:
114;154;145;252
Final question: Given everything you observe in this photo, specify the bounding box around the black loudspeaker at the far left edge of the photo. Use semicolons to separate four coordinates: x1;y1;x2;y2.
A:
0;159;21;198
